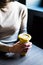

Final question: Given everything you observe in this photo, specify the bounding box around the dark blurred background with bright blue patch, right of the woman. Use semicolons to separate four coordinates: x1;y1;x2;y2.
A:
17;0;43;48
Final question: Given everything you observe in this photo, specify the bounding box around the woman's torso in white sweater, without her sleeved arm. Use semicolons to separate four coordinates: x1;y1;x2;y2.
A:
0;2;21;42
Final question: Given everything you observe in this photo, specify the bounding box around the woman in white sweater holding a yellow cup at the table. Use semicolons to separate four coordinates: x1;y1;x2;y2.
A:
0;0;32;54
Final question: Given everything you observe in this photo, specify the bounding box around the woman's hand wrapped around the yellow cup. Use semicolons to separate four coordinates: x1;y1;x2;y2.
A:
11;41;32;54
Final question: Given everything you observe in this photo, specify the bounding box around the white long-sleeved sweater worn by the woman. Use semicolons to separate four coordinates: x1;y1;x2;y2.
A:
0;1;27;42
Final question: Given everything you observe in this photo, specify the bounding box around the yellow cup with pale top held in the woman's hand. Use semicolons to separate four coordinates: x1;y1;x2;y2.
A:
18;34;31;56
